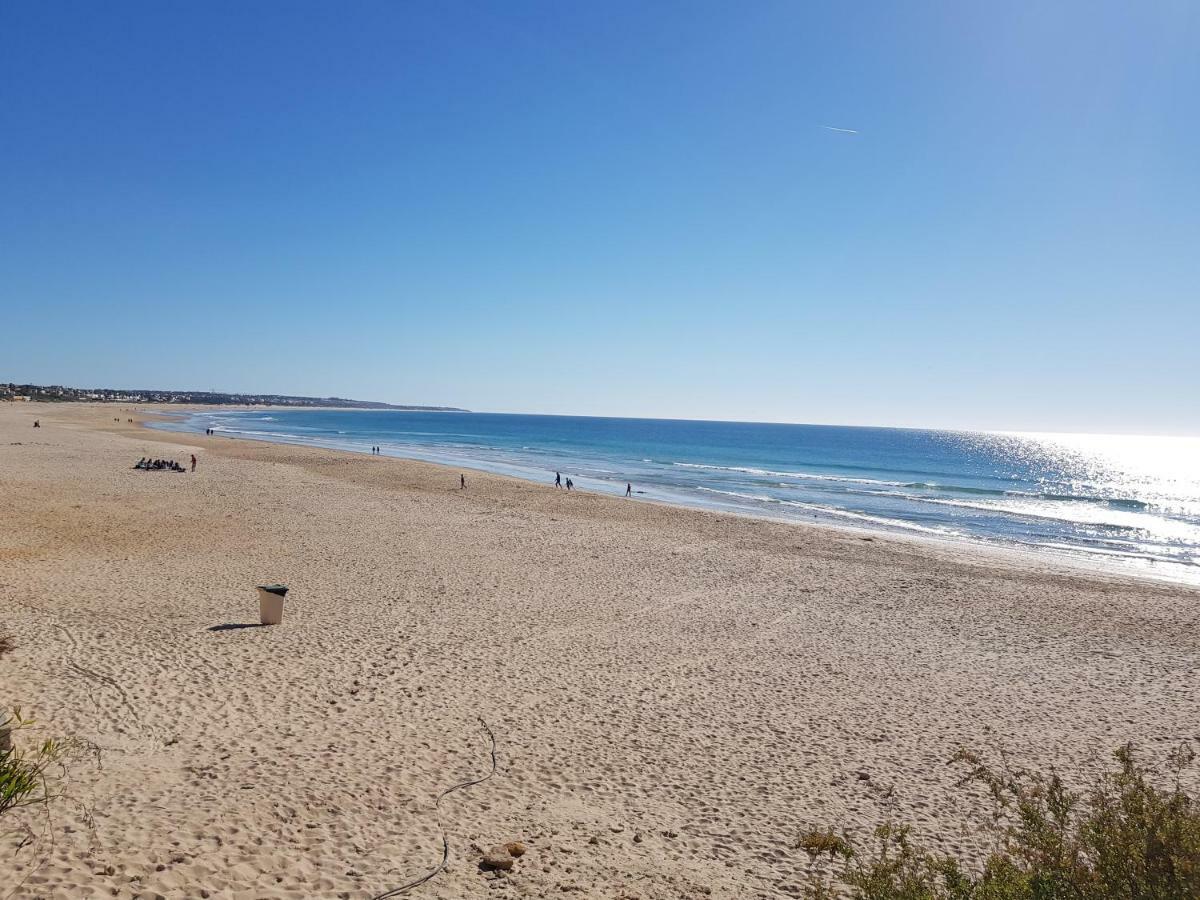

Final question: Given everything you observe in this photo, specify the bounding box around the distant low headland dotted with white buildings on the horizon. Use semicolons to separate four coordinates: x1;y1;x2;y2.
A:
0;384;467;413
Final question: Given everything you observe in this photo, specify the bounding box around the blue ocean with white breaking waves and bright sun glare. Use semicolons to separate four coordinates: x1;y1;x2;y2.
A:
154;409;1200;584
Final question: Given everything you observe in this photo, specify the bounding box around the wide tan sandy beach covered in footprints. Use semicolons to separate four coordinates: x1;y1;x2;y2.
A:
0;404;1200;900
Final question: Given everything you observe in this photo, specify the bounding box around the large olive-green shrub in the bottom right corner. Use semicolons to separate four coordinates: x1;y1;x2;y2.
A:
800;744;1200;900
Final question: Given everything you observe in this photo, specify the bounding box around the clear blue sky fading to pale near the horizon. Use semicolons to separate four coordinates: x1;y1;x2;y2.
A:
0;0;1200;433
